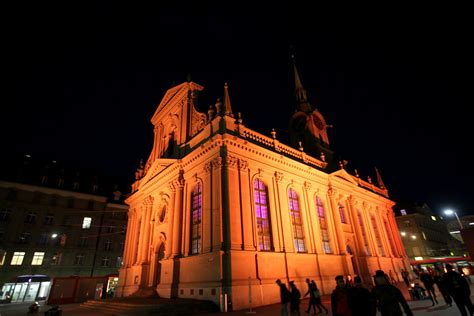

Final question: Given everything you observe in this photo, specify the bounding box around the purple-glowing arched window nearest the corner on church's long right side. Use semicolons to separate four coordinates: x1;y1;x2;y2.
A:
253;179;272;251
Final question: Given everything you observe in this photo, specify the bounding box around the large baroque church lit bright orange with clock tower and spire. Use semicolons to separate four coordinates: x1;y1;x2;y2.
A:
116;63;409;309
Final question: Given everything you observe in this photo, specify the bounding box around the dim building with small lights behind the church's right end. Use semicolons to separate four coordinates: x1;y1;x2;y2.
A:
396;203;464;264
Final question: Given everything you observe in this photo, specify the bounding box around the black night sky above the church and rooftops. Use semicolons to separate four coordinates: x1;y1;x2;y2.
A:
1;2;474;215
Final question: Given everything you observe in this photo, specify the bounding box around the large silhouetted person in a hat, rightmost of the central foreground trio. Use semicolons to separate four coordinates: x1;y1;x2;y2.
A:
372;270;413;316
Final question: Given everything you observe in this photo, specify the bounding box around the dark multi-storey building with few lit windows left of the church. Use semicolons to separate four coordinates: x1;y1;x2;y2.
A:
0;156;127;302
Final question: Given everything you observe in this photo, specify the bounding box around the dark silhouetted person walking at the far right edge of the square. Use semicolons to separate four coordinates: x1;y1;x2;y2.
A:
443;264;474;316
